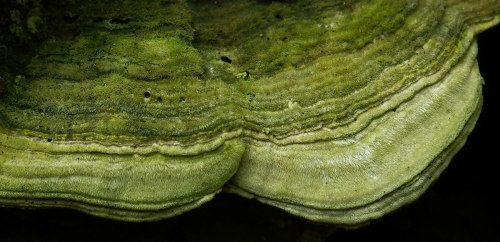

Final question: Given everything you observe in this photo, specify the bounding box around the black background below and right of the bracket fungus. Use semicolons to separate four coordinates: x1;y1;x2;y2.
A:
0;17;500;242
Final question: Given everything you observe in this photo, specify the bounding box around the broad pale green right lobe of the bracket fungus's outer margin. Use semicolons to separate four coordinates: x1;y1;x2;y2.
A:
225;39;482;224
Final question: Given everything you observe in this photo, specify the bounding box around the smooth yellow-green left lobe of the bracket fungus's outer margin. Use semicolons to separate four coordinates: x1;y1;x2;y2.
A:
0;140;244;221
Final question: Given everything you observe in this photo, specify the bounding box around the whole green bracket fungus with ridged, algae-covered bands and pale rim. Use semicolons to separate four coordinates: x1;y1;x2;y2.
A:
0;0;500;224
